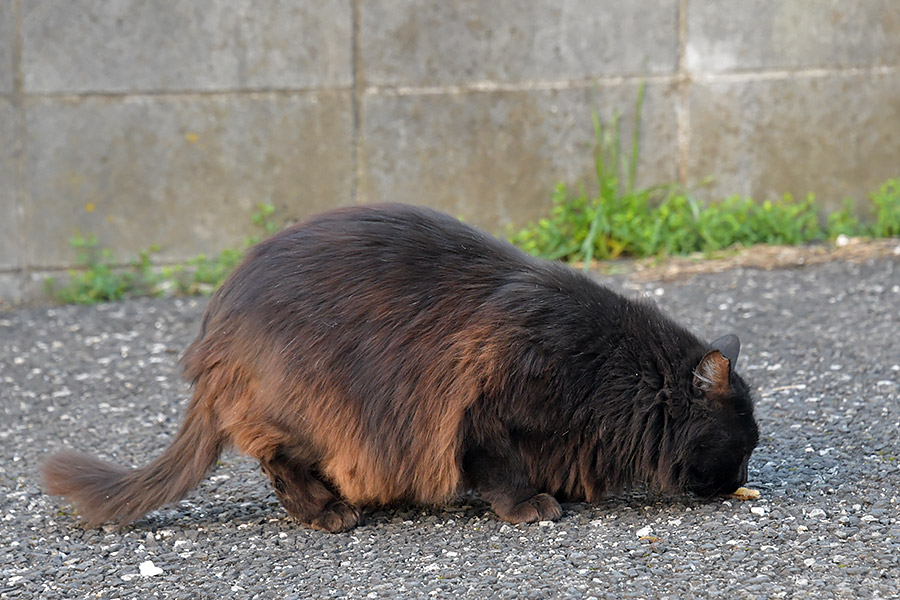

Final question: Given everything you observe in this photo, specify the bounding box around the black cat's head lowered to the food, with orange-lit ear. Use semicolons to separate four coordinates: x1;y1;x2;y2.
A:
678;335;759;497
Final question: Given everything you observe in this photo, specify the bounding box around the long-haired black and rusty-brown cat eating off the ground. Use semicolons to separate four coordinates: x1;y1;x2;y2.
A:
42;204;758;532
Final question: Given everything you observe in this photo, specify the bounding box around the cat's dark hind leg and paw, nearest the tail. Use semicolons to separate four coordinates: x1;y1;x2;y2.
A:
260;448;361;533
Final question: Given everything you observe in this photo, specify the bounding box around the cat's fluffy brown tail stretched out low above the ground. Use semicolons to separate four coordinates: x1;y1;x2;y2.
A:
41;410;223;527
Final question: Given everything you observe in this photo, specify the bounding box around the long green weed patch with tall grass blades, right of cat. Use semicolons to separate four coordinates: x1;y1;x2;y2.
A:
510;86;900;268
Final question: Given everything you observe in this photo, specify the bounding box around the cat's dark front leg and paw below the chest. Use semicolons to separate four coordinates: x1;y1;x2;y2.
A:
463;440;562;523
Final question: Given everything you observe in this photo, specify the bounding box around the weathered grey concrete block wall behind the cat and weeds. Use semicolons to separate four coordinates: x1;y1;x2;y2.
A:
0;0;900;301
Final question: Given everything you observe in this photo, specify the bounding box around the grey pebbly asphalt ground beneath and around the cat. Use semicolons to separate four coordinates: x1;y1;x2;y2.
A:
0;258;900;599
